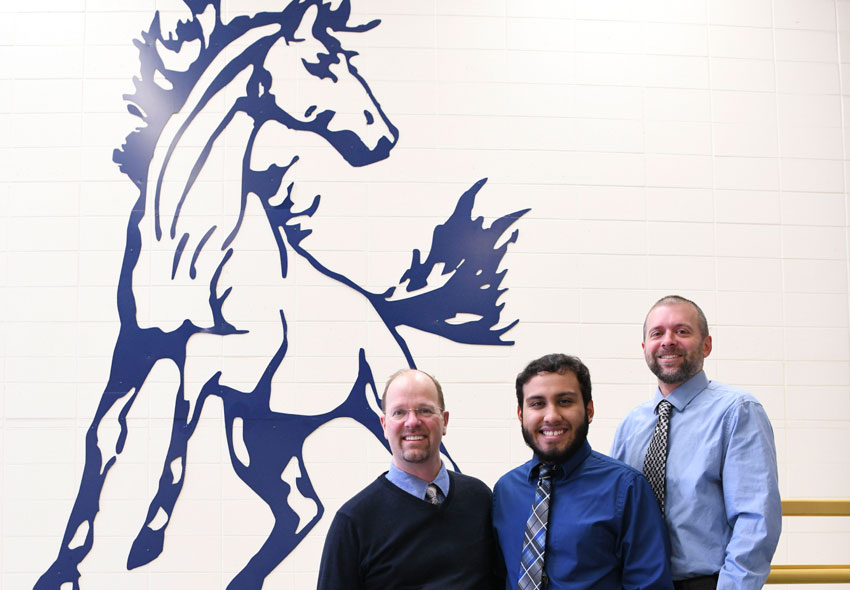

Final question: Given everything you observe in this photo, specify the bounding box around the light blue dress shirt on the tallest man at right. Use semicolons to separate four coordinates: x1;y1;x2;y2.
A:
611;371;782;590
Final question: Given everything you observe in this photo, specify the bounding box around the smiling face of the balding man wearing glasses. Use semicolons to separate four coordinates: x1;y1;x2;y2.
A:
381;371;449;481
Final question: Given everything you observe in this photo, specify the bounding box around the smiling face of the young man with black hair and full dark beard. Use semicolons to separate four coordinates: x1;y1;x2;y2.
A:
517;371;593;463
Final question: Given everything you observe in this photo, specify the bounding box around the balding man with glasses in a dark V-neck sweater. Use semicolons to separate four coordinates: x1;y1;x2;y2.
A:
318;369;504;590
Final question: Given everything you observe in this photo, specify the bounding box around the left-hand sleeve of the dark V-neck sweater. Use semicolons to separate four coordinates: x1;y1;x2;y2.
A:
317;512;363;590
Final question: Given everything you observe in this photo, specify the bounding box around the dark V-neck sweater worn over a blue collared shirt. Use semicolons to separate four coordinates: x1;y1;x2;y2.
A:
318;471;504;590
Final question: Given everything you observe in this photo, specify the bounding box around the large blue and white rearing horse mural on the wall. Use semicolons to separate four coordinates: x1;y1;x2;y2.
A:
35;0;527;590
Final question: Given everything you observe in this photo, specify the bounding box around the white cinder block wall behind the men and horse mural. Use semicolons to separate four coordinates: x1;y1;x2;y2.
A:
0;0;850;590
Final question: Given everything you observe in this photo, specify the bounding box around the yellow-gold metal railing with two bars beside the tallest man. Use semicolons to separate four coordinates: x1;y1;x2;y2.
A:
767;500;850;584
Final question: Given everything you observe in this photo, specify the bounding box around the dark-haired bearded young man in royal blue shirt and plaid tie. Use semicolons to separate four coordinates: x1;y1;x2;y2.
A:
493;354;673;590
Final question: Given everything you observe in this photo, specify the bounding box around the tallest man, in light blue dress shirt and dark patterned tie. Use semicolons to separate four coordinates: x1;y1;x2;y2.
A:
611;295;782;590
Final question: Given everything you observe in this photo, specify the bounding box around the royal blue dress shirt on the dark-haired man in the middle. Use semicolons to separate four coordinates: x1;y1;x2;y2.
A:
493;441;673;590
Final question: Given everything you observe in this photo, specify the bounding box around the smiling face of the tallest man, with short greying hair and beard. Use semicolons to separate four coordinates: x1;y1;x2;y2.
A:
642;303;711;396
